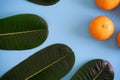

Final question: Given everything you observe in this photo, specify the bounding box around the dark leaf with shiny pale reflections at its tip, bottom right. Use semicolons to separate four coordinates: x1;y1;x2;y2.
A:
71;59;114;80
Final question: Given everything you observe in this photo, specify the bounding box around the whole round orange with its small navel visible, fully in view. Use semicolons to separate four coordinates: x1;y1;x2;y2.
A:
89;16;114;40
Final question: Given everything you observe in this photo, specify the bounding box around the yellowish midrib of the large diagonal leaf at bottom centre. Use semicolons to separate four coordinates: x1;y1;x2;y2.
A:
25;54;69;80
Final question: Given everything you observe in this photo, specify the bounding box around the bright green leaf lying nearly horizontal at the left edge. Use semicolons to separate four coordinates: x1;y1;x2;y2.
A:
0;14;48;50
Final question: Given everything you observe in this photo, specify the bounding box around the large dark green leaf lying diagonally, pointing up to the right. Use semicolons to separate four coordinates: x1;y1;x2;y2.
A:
1;44;75;80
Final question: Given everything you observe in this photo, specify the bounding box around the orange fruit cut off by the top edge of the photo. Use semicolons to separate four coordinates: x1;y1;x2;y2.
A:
96;0;120;10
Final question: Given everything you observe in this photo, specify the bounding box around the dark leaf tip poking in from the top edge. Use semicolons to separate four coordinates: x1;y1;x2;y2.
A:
28;0;59;6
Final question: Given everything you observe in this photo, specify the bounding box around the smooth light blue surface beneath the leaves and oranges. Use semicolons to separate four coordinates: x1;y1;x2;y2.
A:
0;0;120;80
